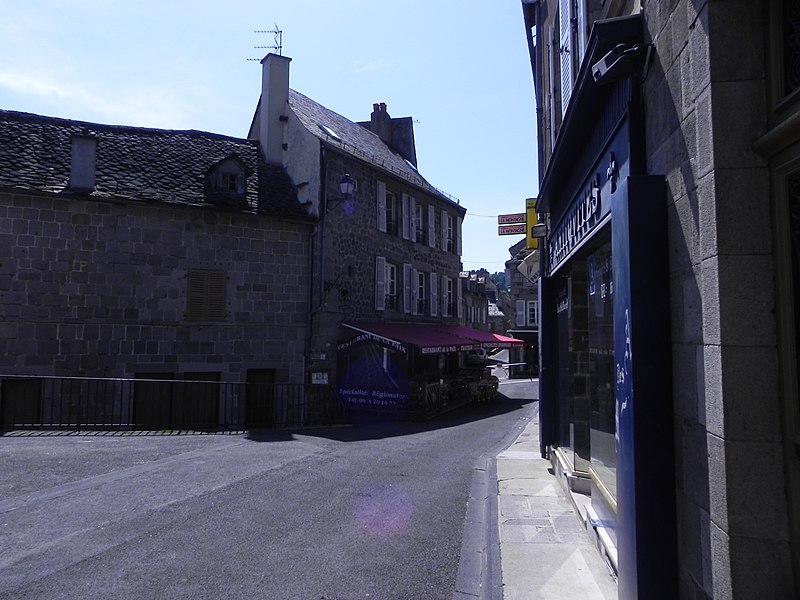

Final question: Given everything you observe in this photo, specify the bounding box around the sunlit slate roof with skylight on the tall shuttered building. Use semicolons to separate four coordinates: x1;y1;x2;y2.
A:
289;89;459;210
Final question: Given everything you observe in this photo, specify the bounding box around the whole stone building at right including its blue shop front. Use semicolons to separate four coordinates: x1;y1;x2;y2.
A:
522;0;800;599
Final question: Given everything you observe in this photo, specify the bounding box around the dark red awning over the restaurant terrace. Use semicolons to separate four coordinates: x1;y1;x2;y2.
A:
342;323;524;354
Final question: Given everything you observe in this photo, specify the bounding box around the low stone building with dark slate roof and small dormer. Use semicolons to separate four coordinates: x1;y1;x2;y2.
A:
0;111;315;426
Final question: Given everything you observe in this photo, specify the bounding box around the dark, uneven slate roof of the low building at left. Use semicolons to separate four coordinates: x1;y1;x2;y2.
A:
0;110;308;218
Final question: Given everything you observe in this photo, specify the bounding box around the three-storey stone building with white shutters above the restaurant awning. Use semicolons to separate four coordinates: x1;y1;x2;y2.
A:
248;54;494;418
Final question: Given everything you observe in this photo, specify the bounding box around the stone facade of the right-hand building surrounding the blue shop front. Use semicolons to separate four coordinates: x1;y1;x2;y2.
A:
523;0;800;599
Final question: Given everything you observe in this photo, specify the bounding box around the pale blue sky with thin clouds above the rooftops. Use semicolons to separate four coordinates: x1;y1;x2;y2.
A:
0;0;538;272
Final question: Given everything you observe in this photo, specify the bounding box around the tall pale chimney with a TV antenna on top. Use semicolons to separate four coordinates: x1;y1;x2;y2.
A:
258;53;292;165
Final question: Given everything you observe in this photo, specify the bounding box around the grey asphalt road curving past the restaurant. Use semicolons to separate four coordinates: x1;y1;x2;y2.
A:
0;382;531;600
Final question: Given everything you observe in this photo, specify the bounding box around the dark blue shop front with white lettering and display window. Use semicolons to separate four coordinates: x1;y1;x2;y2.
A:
537;14;676;598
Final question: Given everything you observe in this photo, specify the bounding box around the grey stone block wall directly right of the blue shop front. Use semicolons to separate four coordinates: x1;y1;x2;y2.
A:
644;0;791;598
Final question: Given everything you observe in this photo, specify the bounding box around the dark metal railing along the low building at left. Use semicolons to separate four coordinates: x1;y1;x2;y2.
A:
0;375;345;431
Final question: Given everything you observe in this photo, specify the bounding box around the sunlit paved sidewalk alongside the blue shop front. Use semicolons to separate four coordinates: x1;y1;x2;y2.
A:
496;403;617;600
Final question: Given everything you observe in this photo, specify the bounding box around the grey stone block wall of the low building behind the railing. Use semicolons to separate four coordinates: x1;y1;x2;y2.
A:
0;193;311;383
